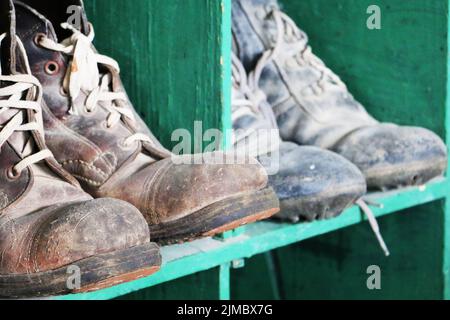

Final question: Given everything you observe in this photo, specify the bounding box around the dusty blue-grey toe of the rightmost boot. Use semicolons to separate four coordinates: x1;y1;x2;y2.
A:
336;125;447;188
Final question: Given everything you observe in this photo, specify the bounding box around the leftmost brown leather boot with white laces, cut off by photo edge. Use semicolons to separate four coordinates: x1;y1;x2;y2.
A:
0;0;161;298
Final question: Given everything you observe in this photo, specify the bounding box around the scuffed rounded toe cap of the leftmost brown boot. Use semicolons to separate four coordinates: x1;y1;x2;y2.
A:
32;199;150;271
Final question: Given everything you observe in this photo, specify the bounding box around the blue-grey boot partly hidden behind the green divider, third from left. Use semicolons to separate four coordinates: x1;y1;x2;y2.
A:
232;55;366;222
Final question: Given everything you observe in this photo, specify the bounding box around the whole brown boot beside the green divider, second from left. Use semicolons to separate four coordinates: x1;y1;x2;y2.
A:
16;0;279;243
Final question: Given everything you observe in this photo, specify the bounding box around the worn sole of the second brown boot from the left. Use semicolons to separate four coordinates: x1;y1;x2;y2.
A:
150;189;280;245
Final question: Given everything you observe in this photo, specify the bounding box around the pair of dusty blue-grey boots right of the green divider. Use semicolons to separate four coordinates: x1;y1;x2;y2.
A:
232;0;447;222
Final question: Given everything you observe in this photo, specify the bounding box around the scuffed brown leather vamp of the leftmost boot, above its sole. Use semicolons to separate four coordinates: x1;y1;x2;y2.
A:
0;199;150;274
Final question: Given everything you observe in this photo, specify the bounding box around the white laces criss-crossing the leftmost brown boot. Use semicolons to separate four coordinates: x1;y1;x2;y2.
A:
0;34;53;176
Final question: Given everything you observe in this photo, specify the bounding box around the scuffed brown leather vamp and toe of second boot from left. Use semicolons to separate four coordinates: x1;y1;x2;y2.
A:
96;157;267;224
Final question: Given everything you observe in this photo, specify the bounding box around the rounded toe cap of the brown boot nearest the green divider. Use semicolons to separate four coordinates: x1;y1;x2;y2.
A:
153;154;268;222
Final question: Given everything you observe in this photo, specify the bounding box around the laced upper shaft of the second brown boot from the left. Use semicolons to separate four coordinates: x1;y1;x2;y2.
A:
12;0;170;191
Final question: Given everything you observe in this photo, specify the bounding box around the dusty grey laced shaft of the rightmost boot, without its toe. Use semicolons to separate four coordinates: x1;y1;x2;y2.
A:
233;0;378;148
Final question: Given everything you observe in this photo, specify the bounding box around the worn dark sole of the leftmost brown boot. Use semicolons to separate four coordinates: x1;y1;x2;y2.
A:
0;243;161;298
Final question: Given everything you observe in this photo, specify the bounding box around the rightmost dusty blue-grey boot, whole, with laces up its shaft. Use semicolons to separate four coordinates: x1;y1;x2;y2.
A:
233;0;447;189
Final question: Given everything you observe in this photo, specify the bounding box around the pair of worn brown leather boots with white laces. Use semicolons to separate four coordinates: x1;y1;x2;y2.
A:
0;0;279;297
